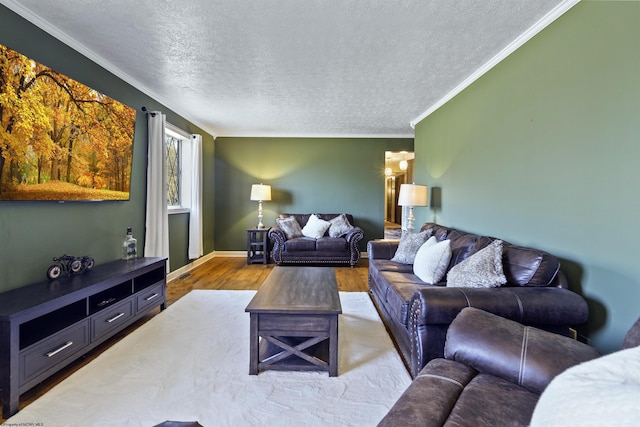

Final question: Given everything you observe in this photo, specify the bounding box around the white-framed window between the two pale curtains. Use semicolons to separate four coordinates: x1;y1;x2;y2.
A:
165;123;191;213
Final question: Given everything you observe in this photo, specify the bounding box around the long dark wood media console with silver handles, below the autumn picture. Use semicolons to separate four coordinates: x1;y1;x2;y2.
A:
0;258;167;418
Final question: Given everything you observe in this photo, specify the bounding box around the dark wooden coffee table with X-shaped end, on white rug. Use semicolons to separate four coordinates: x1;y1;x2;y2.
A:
245;267;342;377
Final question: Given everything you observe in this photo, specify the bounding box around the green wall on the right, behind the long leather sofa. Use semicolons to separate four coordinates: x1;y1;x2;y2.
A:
415;1;640;352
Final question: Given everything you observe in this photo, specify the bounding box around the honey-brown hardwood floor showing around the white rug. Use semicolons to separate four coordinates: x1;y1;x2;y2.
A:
0;257;369;423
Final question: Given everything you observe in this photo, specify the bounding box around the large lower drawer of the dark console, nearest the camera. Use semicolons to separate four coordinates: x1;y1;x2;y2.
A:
18;319;89;386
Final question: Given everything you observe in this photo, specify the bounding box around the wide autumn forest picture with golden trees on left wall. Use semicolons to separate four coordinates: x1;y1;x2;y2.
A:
0;44;136;202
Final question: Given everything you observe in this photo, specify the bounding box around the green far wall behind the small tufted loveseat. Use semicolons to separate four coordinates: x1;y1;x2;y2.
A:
215;138;413;251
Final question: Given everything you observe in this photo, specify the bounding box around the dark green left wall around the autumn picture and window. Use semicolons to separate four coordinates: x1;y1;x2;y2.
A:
0;6;214;291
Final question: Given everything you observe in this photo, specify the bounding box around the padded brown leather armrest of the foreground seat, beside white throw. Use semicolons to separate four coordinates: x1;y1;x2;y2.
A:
444;307;600;393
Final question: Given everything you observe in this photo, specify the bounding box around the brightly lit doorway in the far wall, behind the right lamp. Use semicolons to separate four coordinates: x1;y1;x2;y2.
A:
384;151;415;239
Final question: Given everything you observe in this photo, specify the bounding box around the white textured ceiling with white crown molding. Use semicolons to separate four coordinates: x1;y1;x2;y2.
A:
0;0;577;137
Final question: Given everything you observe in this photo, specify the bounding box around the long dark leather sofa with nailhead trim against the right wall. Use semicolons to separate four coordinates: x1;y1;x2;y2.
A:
367;223;588;377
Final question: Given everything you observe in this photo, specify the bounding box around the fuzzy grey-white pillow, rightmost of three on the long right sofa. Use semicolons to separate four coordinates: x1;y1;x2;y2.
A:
447;240;507;288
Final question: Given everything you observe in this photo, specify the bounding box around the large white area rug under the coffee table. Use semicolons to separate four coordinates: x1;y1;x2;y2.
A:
7;290;411;427
